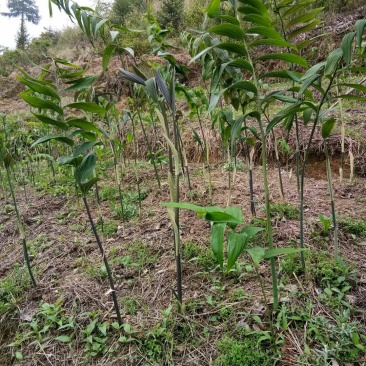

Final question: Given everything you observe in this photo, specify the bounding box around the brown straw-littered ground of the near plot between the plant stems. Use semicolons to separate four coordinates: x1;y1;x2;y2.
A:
0;156;366;365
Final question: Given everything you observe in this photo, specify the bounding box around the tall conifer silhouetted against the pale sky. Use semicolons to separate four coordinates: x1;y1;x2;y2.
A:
1;0;41;50
